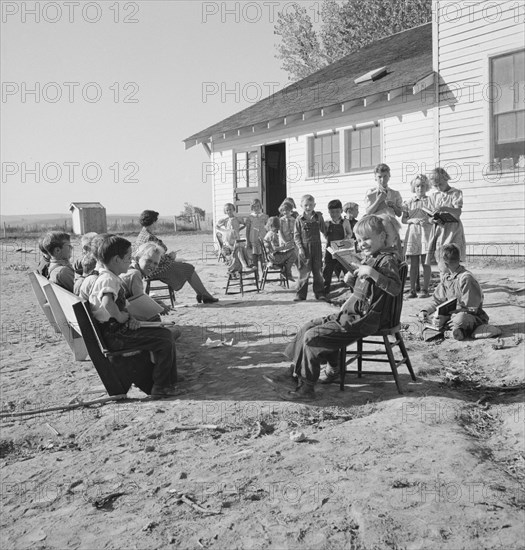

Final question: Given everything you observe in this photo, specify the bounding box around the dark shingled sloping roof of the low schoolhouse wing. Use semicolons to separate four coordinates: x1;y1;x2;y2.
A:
184;23;433;148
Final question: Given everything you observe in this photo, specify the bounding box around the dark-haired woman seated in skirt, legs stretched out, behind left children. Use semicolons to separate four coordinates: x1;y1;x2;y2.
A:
135;210;219;304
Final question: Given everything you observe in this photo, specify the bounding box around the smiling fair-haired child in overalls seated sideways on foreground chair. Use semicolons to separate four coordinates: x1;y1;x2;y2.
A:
278;215;401;399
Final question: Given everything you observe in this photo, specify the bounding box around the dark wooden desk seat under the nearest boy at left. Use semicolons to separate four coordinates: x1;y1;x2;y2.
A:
73;301;153;395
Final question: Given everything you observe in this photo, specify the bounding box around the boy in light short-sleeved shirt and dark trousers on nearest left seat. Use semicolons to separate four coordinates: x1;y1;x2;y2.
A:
89;235;180;398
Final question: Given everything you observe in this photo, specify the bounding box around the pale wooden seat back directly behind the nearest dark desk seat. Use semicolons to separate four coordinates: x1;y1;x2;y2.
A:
44;281;88;361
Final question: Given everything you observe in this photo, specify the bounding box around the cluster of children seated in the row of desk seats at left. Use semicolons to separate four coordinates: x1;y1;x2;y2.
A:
39;231;180;398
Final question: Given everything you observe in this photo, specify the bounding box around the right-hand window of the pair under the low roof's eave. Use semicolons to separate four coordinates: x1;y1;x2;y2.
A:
345;126;381;172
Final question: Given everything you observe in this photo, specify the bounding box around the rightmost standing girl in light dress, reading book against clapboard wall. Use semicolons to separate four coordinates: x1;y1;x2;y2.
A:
426;167;467;264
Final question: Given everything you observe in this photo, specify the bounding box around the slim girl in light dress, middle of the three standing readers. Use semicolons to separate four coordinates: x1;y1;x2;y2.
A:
401;174;432;298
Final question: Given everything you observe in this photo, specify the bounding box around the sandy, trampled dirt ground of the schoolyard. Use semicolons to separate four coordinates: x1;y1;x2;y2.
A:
0;234;525;550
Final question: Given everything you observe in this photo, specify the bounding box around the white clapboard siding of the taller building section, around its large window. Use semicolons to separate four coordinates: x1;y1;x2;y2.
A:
434;0;525;247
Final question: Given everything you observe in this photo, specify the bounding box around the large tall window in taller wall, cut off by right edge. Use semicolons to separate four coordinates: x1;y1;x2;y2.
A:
489;50;525;171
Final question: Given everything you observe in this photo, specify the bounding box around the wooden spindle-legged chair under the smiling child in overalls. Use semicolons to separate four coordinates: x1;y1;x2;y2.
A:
339;262;416;393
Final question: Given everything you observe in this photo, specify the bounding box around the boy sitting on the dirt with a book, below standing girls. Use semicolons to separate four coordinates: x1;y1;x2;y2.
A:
419;243;492;340
